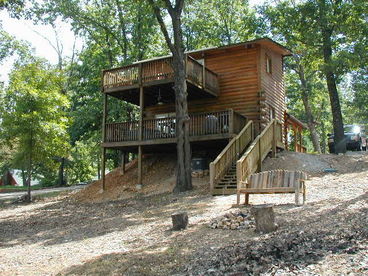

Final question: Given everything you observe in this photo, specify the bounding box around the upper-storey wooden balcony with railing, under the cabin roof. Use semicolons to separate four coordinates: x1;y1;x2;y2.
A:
103;55;219;106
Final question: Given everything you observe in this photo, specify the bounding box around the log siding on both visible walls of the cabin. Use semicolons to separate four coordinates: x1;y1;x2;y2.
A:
145;44;286;134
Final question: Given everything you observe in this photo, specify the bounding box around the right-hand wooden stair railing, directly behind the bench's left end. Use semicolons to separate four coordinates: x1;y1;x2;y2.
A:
236;119;282;204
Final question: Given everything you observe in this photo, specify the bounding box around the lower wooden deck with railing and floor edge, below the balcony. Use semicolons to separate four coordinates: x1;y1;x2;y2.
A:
103;110;246;147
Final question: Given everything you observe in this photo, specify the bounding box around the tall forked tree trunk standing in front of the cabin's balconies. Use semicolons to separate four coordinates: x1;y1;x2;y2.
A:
149;0;192;192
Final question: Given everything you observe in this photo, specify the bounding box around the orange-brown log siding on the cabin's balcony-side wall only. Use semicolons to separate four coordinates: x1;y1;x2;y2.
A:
145;45;260;129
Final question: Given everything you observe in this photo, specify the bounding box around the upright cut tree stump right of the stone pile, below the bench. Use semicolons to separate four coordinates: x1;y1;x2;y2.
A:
251;204;277;233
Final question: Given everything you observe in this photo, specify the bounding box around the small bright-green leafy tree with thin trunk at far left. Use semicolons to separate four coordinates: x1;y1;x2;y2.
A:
1;59;69;201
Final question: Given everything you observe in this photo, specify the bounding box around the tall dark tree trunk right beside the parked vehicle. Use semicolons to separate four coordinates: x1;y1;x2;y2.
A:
319;0;346;153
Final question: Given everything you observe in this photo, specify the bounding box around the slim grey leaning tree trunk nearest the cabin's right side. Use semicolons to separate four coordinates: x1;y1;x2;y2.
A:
298;64;321;153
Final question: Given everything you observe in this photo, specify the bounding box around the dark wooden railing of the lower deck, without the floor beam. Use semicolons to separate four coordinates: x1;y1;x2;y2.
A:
105;110;246;142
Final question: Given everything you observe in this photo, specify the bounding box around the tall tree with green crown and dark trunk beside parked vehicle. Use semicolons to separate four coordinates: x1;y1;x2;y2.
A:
262;0;367;153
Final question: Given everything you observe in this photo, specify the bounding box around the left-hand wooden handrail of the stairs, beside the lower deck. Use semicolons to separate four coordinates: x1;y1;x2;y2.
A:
210;121;254;193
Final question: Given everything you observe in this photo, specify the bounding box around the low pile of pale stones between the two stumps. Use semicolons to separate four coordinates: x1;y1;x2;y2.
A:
209;211;254;230
